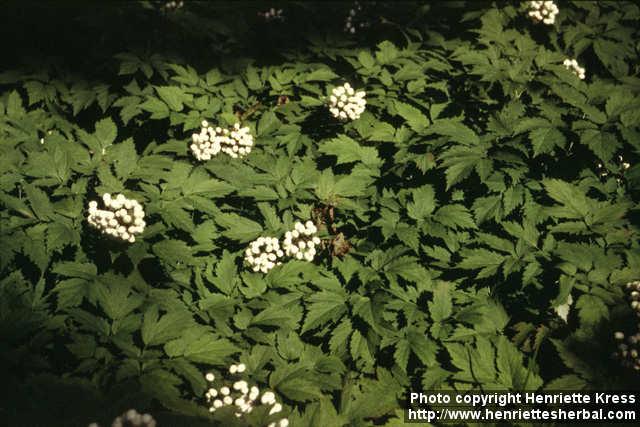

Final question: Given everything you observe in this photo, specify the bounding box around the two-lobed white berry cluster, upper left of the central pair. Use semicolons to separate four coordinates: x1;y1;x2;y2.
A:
190;120;253;160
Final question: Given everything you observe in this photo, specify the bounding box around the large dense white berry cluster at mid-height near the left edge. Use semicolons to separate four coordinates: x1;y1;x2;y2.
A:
87;193;146;243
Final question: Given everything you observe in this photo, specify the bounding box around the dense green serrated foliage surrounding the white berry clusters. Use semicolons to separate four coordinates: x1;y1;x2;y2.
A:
0;1;640;426
